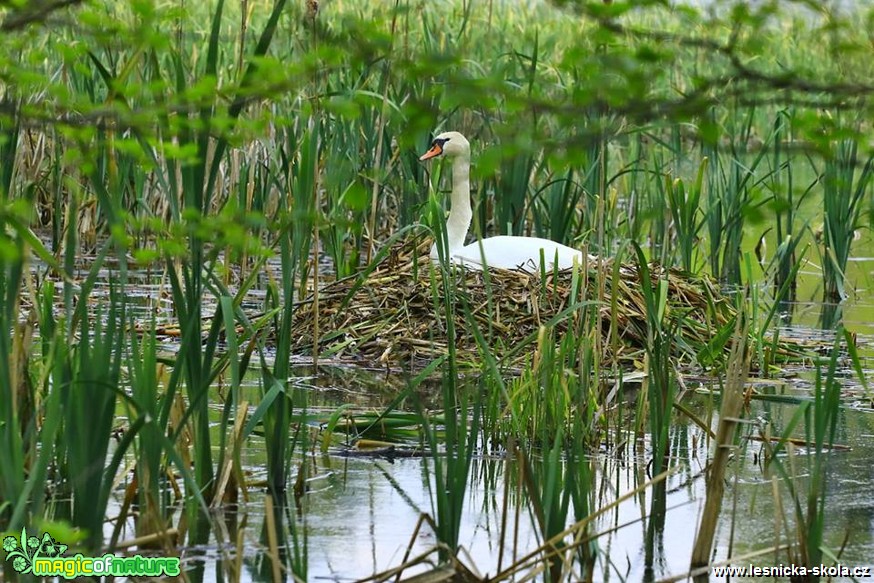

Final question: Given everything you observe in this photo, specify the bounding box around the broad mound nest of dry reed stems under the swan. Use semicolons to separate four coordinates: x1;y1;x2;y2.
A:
292;242;736;368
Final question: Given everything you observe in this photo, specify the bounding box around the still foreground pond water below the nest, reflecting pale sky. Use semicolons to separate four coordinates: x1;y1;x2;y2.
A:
172;370;874;581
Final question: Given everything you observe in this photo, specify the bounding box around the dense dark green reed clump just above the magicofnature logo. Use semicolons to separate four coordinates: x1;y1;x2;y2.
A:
46;140;139;550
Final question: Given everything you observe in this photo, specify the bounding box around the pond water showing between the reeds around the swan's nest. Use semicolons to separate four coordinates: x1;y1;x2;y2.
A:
56;246;874;581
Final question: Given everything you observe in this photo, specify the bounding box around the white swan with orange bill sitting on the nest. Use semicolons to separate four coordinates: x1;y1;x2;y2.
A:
419;132;583;271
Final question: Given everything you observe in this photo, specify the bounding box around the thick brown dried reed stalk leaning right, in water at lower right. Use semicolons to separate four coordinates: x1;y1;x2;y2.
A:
691;312;750;581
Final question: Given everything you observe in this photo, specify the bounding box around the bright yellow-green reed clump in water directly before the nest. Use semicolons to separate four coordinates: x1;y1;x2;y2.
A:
461;253;600;580
